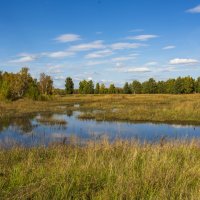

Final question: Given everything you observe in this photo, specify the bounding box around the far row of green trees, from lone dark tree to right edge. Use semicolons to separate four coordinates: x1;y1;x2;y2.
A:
65;76;200;94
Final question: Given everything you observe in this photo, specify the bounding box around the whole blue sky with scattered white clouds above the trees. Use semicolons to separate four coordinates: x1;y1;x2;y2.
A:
0;0;200;88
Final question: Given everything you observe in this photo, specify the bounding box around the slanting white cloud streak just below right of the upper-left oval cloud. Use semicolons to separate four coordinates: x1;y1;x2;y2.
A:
69;40;105;52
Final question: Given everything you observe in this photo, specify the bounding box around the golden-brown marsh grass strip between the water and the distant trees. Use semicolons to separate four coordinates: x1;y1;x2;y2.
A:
0;94;200;124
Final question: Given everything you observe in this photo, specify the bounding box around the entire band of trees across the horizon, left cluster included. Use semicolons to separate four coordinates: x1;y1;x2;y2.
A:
0;68;200;100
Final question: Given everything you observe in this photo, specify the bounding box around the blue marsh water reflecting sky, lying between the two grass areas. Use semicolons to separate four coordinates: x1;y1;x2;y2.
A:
0;111;200;146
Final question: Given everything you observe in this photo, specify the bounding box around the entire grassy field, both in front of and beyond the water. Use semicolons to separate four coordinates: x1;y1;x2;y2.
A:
0;94;200;200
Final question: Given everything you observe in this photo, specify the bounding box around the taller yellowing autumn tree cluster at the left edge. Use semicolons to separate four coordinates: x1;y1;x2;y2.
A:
0;68;53;100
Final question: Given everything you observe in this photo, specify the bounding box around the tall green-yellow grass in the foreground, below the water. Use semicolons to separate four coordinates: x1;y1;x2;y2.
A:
0;140;200;200
